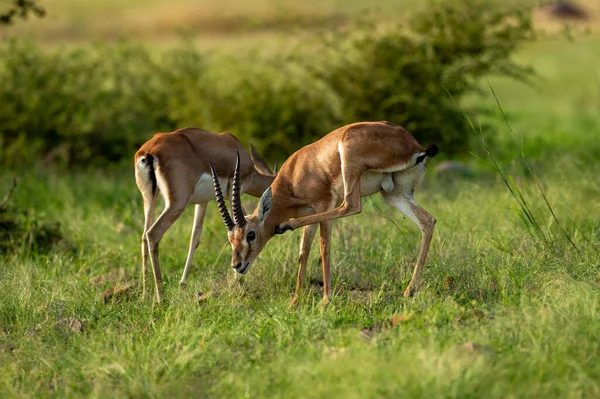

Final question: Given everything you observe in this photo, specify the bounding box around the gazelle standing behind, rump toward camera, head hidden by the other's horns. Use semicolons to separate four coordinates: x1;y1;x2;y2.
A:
135;128;275;302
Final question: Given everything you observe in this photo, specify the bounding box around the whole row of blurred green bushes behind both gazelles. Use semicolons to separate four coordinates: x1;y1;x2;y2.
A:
0;0;532;167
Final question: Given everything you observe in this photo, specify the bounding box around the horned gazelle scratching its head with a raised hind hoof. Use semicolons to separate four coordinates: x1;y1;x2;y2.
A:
213;122;438;303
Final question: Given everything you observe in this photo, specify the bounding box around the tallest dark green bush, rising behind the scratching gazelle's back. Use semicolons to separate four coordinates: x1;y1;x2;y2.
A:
298;0;532;154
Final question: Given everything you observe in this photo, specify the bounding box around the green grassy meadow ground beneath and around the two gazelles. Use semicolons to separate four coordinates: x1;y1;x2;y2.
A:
0;1;600;398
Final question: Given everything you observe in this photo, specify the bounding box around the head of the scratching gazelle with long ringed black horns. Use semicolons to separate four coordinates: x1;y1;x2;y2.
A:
210;154;275;274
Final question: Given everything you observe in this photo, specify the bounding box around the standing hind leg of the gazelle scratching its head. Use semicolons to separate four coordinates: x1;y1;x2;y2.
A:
383;191;436;297
